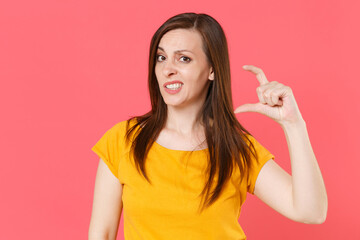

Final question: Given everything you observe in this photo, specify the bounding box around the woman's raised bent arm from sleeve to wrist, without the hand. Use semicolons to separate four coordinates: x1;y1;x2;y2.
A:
254;120;328;224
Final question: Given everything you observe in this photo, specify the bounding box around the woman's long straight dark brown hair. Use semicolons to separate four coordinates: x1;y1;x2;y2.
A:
126;12;257;214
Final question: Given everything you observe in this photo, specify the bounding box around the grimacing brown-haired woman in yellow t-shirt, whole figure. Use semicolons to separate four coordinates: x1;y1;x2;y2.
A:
89;13;327;240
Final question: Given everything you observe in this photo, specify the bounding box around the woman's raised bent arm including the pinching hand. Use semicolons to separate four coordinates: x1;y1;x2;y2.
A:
234;65;328;223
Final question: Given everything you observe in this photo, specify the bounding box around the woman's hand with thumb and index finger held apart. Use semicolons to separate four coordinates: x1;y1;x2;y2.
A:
234;65;303;125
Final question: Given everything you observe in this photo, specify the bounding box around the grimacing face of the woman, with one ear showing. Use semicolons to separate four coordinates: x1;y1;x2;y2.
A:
155;29;214;107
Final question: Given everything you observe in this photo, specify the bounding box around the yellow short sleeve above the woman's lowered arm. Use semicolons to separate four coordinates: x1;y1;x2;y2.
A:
91;122;124;179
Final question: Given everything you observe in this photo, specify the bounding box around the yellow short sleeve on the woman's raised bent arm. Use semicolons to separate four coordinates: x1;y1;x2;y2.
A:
247;134;275;195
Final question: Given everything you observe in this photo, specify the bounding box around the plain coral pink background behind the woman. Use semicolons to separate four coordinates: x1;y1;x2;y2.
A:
0;0;360;239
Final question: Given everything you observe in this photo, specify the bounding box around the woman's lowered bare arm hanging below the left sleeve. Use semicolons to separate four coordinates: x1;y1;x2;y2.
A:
88;158;122;240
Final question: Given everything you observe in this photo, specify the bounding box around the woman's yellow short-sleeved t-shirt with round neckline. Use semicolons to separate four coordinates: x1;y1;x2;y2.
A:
92;120;275;240
